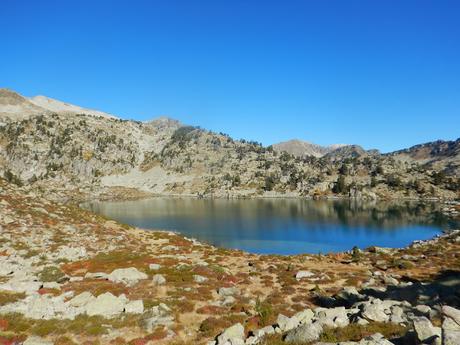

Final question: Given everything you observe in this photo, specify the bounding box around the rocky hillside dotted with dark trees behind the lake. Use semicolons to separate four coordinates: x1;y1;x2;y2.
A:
0;92;460;199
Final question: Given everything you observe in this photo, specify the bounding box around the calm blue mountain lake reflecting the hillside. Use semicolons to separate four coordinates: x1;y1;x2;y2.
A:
82;198;459;254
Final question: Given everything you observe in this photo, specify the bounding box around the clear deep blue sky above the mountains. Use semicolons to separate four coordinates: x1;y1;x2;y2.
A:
0;0;460;152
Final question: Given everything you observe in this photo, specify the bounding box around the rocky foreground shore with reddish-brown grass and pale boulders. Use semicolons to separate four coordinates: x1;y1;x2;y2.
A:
0;180;460;345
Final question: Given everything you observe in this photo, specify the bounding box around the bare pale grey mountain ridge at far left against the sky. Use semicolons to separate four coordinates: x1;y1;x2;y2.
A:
0;89;116;119
